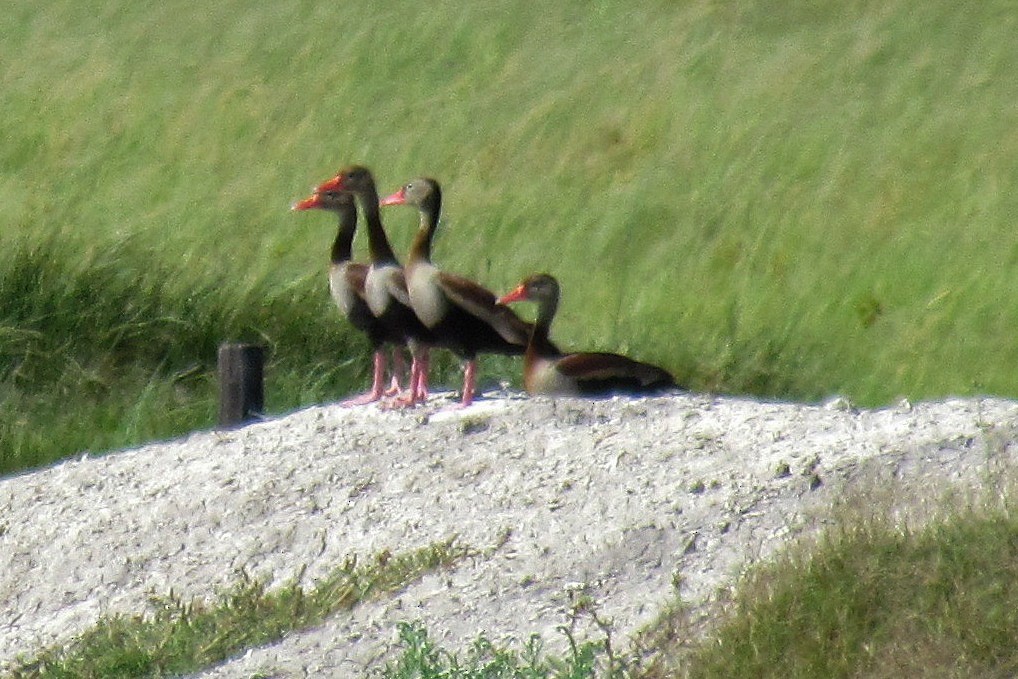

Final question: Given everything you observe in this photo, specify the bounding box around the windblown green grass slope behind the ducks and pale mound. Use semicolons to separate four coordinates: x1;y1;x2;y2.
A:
0;0;1018;469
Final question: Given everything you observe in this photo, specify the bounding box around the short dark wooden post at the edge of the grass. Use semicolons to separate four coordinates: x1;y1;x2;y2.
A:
219;343;265;428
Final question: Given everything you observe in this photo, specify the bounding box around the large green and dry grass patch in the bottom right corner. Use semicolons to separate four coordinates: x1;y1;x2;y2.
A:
637;478;1018;679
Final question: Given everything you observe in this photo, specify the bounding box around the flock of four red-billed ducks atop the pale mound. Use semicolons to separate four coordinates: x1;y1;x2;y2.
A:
293;165;676;406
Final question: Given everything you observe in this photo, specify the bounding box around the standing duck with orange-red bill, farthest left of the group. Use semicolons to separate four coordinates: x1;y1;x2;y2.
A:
291;191;403;405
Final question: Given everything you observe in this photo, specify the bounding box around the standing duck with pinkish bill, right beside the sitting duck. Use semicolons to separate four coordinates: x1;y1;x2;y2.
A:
382;177;531;406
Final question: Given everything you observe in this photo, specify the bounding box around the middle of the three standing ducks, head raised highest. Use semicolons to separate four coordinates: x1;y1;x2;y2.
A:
317;165;434;405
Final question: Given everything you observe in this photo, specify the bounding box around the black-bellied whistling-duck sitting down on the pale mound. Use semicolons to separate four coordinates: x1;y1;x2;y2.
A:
499;274;676;396
